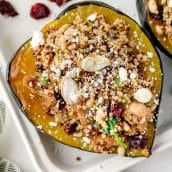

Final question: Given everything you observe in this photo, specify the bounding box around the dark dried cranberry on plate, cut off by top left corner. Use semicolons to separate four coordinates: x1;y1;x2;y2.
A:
0;0;18;17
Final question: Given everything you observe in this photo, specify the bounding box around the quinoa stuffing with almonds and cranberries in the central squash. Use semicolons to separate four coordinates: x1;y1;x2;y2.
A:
24;13;158;156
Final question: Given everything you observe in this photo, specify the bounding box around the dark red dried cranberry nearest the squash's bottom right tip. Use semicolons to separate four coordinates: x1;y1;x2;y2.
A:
127;135;148;149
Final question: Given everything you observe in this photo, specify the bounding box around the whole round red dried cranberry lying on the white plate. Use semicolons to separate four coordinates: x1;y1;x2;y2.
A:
30;3;50;19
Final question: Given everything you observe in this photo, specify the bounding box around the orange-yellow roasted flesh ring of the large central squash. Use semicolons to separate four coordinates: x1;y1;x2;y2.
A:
9;5;162;156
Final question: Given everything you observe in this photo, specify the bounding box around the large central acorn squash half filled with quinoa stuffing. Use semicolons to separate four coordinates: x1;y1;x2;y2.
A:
8;2;162;157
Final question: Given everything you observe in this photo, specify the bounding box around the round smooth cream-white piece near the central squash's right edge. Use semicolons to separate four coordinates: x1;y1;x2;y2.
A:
134;88;152;103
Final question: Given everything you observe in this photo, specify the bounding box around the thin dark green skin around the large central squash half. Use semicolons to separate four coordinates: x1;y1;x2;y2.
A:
7;1;163;157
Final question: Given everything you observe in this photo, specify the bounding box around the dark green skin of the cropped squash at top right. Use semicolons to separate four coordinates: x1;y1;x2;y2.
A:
136;0;172;58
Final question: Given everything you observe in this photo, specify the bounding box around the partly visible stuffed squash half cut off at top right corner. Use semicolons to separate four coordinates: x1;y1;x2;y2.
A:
137;0;172;57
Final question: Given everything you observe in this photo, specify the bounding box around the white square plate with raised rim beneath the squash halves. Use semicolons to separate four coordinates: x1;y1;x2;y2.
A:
0;0;172;172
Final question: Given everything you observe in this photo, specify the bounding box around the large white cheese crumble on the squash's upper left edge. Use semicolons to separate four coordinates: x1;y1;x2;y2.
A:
31;31;45;49
